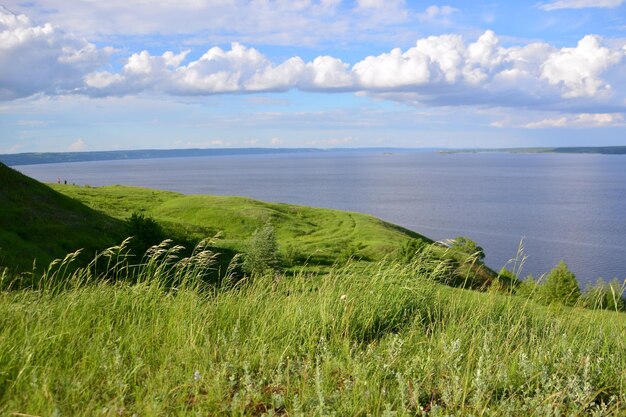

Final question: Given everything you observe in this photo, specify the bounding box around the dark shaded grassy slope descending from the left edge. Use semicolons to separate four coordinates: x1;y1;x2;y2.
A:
0;164;124;269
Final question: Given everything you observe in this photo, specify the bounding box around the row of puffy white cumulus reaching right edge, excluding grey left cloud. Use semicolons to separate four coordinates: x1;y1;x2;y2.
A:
28;31;626;109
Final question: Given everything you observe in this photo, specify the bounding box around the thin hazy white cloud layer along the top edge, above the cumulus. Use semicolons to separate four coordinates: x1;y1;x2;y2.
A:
3;0;416;46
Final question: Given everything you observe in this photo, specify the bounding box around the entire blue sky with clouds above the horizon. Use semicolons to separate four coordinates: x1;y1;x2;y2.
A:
0;0;626;153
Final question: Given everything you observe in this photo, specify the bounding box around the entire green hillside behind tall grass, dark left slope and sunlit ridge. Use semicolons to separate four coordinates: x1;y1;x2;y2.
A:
0;165;495;287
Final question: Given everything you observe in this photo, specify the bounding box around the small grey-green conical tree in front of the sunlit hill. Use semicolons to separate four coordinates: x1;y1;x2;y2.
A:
243;222;280;274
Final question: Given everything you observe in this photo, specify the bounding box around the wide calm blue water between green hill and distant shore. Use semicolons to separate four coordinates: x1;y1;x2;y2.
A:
17;151;626;283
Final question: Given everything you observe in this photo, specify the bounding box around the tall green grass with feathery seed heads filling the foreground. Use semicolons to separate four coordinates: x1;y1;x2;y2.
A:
0;244;626;416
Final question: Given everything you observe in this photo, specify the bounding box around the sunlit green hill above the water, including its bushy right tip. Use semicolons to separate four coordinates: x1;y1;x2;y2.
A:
52;184;497;288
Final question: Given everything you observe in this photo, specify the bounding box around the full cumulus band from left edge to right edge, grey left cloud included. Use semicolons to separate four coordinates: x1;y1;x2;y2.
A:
0;6;626;113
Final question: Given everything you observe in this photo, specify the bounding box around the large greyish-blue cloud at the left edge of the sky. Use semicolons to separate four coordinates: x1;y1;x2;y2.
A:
0;6;112;100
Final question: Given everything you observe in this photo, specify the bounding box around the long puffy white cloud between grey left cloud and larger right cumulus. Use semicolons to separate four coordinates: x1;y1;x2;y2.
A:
85;42;353;96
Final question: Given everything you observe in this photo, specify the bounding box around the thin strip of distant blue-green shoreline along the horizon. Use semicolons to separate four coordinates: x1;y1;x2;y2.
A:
0;146;626;166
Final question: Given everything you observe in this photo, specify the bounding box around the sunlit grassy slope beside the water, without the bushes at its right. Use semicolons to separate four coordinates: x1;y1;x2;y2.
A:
53;185;429;263
